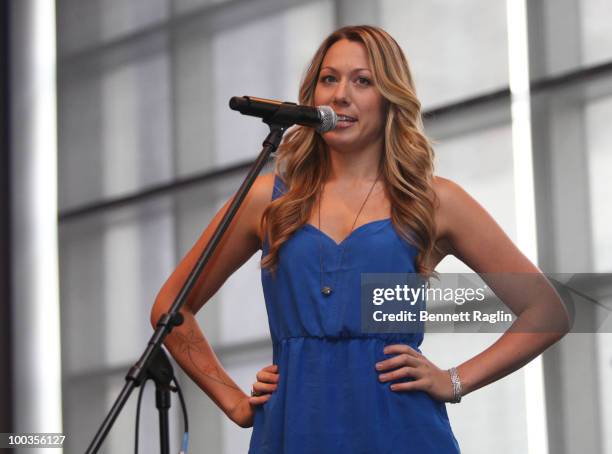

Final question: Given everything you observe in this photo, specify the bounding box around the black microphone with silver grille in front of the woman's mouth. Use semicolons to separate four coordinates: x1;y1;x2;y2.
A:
230;96;338;132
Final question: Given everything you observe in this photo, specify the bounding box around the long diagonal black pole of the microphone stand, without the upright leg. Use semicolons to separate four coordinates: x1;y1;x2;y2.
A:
86;123;290;454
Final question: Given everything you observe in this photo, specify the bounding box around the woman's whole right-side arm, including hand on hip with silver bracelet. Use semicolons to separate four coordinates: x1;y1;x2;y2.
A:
375;178;569;401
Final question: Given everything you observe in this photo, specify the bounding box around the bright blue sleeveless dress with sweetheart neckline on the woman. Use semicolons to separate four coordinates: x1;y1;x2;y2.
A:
249;176;459;454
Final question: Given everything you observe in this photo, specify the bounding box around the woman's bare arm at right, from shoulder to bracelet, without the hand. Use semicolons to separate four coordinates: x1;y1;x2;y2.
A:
436;178;569;394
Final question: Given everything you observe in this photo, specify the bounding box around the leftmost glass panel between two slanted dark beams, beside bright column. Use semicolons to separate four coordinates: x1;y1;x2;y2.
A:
59;35;172;209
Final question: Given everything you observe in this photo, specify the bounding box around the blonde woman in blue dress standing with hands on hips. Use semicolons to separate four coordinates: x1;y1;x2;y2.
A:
152;26;568;454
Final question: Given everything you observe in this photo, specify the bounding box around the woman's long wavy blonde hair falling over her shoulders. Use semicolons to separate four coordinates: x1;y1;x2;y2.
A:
261;25;436;277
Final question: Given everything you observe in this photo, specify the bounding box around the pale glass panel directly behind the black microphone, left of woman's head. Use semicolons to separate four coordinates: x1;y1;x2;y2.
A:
176;1;333;174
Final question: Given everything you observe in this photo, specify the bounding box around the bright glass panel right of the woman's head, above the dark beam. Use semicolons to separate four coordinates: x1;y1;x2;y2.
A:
380;0;508;108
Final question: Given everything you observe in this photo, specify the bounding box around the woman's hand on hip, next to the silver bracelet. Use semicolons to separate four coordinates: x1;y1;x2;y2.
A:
375;344;454;402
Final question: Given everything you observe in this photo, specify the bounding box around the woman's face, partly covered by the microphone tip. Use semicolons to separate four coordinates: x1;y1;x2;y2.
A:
314;39;385;151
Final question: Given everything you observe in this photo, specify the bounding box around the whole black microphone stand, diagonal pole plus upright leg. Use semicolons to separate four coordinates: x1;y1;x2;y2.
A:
86;120;292;454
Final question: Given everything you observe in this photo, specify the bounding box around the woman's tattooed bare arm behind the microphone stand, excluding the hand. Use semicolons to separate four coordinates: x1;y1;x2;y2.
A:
151;174;274;427
